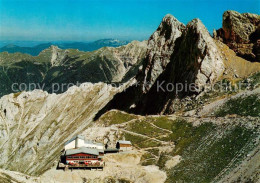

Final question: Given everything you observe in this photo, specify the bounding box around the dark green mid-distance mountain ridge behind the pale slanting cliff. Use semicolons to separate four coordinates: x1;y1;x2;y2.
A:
0;40;147;96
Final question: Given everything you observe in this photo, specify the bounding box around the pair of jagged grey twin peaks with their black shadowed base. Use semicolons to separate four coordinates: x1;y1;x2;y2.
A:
100;15;224;114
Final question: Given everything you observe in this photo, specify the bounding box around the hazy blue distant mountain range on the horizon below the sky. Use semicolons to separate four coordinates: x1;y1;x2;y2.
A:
0;39;129;56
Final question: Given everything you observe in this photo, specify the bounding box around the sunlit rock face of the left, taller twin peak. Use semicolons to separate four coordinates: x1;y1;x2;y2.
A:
141;14;185;92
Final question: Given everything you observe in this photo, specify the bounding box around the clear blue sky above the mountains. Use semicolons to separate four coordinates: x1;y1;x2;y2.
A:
0;0;260;41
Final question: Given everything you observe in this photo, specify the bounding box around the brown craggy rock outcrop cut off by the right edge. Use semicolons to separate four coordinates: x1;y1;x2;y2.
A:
215;11;260;62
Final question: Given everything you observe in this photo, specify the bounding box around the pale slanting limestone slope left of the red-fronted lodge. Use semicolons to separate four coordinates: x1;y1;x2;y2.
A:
0;83;117;175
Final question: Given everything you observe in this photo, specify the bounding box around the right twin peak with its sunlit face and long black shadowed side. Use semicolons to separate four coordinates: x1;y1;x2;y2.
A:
133;19;224;114
